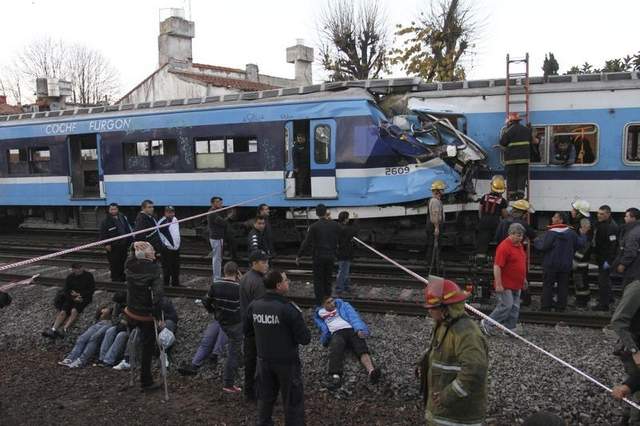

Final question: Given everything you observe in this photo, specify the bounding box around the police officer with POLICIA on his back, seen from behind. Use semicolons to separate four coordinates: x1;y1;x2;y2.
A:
243;270;311;426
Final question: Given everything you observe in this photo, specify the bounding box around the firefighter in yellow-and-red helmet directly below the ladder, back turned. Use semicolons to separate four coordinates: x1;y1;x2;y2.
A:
476;175;507;260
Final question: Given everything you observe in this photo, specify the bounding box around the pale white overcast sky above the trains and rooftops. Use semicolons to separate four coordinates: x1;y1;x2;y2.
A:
0;0;640;102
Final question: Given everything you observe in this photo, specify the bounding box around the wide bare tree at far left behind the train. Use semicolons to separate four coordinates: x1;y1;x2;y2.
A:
2;38;119;105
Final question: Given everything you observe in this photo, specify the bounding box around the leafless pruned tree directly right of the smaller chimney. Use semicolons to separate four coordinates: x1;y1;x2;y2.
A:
319;0;389;81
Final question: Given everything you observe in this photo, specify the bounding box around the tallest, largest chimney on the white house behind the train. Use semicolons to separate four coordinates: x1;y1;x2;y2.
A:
158;9;195;67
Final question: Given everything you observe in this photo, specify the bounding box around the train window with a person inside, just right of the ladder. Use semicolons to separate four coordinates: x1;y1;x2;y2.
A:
549;124;598;165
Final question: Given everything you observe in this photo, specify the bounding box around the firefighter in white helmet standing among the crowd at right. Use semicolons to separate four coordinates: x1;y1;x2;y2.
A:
569;200;593;308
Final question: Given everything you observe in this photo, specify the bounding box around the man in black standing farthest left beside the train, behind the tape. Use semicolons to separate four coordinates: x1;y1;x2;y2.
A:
100;203;133;282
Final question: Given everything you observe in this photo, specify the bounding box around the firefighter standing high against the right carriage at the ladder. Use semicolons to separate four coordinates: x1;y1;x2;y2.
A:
500;112;533;200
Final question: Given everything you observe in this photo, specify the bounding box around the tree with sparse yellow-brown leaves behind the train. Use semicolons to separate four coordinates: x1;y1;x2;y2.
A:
392;0;477;81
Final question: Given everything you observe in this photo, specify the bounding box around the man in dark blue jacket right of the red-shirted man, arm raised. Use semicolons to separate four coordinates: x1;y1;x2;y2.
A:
534;212;589;312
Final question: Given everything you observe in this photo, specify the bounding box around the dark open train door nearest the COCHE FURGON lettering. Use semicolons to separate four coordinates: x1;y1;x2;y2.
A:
68;134;104;198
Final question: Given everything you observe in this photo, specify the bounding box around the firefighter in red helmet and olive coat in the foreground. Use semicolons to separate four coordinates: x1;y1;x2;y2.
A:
416;276;489;425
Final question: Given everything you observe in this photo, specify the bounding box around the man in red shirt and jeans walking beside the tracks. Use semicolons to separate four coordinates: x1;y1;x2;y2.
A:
480;223;527;336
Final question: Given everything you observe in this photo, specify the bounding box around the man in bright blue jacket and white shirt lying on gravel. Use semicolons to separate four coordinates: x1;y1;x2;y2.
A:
314;297;381;389
